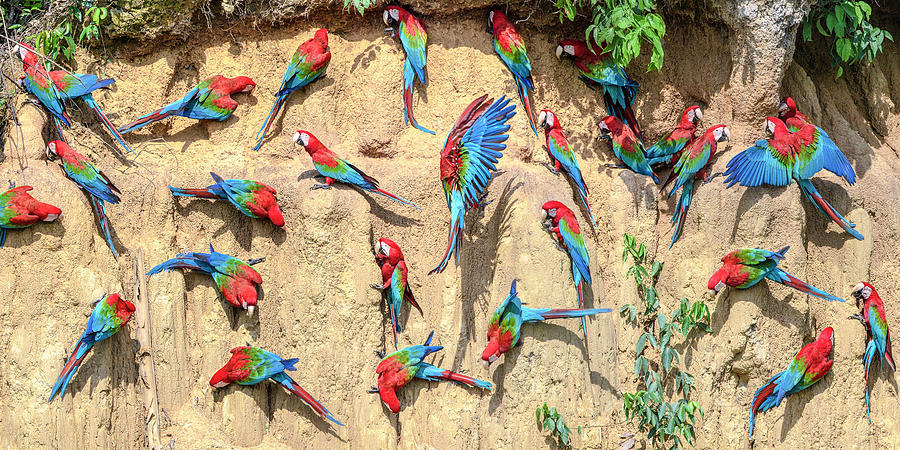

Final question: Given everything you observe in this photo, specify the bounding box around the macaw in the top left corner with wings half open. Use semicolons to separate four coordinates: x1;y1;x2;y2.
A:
13;43;134;153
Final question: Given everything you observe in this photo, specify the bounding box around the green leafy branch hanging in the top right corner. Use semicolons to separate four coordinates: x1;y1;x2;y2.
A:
801;0;894;78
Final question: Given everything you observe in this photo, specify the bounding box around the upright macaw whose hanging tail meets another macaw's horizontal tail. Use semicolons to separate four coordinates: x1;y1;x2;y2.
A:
541;201;591;341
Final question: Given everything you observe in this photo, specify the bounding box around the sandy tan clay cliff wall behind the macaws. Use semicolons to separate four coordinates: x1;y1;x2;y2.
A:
0;0;900;448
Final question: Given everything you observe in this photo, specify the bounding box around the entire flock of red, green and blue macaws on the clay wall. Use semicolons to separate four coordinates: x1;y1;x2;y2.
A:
0;5;894;442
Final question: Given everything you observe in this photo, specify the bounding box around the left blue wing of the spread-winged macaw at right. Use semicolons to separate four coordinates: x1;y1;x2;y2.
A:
725;139;794;187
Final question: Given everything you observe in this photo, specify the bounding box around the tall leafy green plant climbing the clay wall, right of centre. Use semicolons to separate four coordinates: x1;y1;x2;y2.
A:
619;233;710;448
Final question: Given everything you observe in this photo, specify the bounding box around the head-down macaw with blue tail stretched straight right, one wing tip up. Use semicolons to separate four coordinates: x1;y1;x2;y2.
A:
481;280;612;364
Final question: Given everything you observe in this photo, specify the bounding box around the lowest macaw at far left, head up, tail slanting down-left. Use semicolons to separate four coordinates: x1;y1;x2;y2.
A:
47;294;134;401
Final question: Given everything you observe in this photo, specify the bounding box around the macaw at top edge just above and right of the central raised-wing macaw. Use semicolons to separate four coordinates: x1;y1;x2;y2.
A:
488;9;538;136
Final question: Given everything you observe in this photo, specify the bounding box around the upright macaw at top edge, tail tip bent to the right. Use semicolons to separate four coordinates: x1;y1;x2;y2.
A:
384;5;434;134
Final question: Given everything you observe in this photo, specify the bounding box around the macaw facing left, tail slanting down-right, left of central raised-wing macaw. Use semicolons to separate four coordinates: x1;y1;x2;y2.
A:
294;130;421;209
